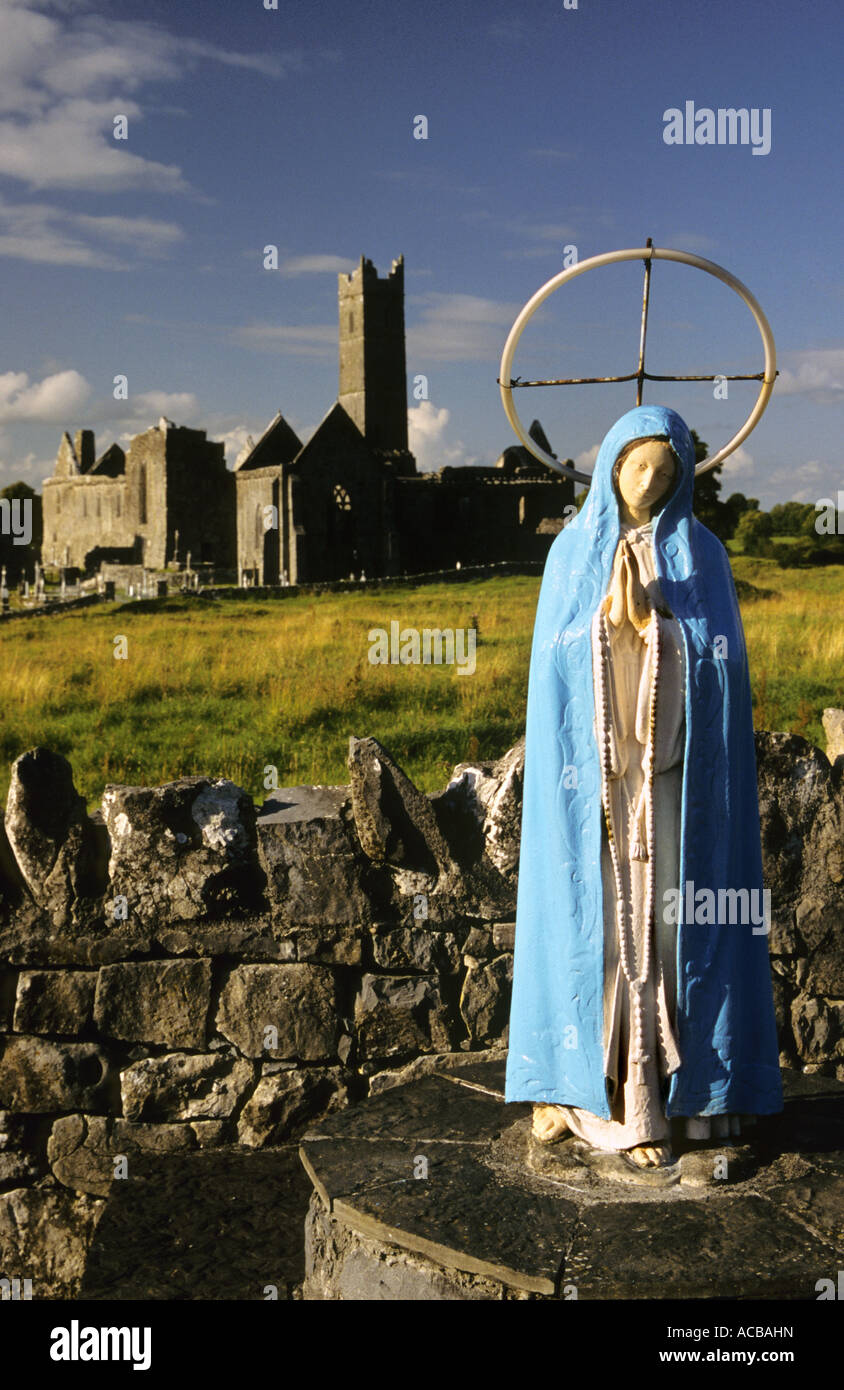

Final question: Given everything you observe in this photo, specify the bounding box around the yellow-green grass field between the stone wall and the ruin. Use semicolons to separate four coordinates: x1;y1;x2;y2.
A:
0;557;844;806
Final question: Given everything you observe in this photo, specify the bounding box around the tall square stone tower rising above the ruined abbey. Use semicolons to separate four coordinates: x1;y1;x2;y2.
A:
338;256;407;449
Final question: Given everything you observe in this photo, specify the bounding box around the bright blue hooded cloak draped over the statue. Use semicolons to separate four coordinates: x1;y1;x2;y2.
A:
505;406;783;1119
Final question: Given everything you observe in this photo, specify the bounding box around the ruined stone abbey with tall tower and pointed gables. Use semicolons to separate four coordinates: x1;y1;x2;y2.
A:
42;256;574;585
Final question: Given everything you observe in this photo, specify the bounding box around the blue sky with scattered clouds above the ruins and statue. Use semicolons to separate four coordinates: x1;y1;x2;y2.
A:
0;0;844;506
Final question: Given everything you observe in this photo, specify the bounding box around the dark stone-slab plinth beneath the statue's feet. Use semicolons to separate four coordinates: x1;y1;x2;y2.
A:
300;1059;844;1300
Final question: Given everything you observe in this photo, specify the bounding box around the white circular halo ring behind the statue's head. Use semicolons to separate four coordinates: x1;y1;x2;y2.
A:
498;246;777;484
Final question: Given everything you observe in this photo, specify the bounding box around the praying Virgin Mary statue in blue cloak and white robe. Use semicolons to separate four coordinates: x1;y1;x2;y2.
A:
506;406;783;1166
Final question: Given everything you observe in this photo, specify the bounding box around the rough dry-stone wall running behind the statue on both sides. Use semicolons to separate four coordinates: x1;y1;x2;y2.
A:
0;734;844;1297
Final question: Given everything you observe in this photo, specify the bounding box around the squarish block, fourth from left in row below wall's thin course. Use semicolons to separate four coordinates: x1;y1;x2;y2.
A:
355;974;449;1062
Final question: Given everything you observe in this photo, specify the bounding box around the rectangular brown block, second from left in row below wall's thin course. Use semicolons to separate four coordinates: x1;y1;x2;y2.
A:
95;960;211;1048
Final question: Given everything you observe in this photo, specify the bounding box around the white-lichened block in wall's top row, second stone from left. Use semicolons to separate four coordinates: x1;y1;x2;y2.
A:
103;777;263;926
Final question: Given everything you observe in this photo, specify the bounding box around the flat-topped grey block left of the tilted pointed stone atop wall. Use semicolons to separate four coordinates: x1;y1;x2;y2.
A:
257;787;368;927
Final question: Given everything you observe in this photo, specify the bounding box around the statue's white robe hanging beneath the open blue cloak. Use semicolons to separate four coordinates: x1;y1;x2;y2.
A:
559;523;738;1150
